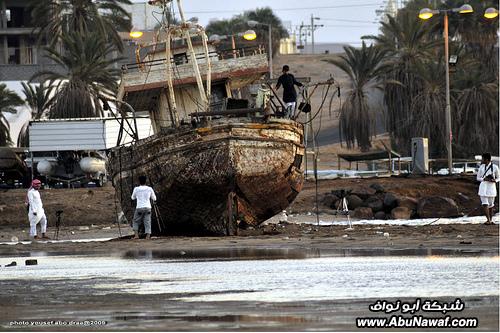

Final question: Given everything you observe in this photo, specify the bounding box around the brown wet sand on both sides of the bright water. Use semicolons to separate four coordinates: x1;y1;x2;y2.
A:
0;218;499;331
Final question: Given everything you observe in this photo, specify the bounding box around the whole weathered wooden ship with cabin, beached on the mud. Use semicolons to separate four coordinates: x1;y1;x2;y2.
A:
108;0;304;235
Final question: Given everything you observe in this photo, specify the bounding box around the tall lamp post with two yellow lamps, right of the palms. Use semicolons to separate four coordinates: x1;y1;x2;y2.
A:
418;4;474;175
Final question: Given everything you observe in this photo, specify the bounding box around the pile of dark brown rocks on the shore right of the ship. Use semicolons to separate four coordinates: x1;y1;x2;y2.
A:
322;183;461;220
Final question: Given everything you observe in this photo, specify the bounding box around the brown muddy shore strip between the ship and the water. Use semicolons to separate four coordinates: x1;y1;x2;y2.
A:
0;223;499;256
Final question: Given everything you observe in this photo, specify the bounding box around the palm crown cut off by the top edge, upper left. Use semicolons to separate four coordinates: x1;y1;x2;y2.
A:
32;0;131;51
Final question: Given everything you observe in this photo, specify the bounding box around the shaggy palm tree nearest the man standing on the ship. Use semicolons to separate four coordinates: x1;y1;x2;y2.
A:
325;42;387;151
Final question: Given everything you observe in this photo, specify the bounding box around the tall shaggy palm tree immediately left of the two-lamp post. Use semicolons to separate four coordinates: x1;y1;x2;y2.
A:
363;10;438;154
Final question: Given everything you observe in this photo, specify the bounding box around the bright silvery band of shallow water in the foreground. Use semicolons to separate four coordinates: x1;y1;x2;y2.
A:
0;250;499;302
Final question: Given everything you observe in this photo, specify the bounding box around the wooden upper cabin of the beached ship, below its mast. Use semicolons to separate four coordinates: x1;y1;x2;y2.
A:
117;38;268;133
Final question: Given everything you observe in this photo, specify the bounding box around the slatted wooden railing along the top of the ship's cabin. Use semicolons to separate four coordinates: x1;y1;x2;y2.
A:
121;45;265;73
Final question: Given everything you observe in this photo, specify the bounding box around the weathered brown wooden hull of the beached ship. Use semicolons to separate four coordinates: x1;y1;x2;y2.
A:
108;118;304;235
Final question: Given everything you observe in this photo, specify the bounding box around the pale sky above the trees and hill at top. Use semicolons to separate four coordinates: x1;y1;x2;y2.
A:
129;0;386;44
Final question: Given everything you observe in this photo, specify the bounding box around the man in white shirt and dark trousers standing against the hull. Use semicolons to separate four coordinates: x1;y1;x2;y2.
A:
132;176;156;239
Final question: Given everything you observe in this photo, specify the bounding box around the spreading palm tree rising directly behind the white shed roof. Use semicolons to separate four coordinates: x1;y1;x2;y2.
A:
31;32;120;118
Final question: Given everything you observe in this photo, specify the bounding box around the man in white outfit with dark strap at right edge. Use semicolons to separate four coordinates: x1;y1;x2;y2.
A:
477;153;500;224
